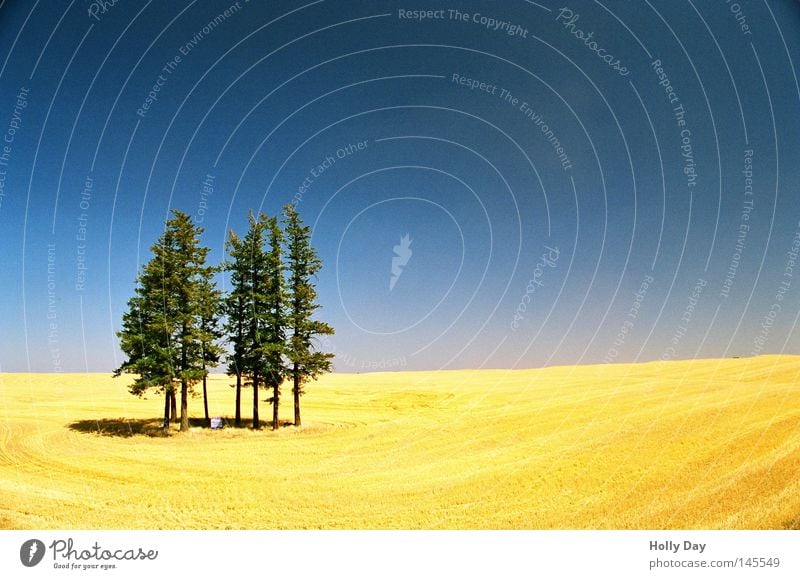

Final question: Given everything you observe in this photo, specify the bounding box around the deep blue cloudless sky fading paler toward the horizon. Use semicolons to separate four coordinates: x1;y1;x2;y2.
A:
0;0;800;372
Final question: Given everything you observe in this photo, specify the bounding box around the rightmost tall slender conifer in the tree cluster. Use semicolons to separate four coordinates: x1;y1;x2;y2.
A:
283;204;333;426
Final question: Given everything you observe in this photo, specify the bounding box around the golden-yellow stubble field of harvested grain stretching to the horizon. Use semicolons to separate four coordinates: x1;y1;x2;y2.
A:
0;356;800;529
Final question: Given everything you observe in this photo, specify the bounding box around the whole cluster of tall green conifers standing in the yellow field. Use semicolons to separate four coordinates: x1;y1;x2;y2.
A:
114;205;333;431
